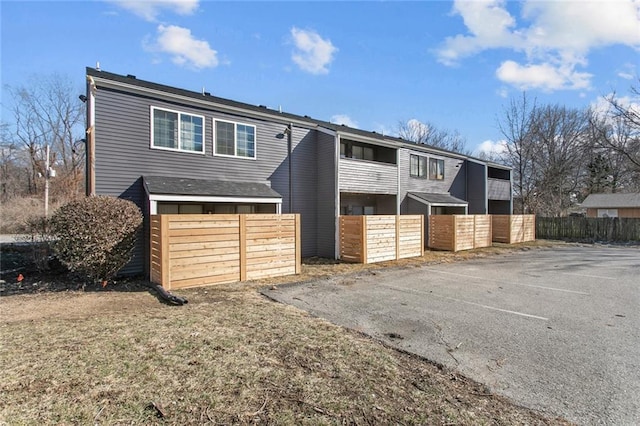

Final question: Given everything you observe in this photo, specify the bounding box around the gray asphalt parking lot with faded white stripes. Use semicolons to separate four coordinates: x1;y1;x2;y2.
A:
263;245;640;425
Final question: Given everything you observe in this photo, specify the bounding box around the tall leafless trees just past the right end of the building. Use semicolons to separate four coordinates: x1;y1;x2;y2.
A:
498;93;592;216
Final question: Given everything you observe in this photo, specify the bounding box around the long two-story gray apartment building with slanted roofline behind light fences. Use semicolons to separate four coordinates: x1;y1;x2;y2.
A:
87;68;512;272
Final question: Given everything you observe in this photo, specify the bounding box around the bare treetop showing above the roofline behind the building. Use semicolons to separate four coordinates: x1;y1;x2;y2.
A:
398;119;470;154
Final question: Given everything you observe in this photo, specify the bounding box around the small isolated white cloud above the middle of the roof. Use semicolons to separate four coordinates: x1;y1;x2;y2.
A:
291;27;338;74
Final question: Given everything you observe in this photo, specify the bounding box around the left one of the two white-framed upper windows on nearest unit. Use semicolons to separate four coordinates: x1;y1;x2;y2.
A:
151;107;204;154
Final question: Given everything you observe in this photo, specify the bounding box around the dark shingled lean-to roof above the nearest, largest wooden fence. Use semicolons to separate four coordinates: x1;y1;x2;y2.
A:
142;176;282;198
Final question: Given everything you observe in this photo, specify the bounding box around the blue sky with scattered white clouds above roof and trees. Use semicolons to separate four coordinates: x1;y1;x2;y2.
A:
0;0;640;153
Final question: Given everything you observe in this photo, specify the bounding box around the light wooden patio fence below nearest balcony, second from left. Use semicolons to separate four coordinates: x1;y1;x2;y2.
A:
340;215;424;263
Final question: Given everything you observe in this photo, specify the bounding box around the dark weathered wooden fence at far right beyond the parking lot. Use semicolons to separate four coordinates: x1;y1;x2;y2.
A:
536;217;640;241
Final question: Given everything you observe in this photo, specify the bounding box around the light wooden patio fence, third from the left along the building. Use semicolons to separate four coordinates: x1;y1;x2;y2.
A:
429;214;492;251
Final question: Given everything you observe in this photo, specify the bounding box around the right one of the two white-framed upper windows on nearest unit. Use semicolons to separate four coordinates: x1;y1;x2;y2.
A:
214;120;256;158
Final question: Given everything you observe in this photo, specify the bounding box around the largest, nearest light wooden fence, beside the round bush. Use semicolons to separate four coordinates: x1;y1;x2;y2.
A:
150;214;301;290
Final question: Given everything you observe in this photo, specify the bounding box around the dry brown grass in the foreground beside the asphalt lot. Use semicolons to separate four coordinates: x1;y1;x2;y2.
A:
0;241;564;425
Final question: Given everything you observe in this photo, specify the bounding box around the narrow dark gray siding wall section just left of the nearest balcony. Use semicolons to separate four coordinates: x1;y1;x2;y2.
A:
316;132;336;258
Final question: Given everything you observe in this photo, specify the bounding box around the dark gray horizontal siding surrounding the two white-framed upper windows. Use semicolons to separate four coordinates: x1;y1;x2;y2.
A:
95;87;294;273
